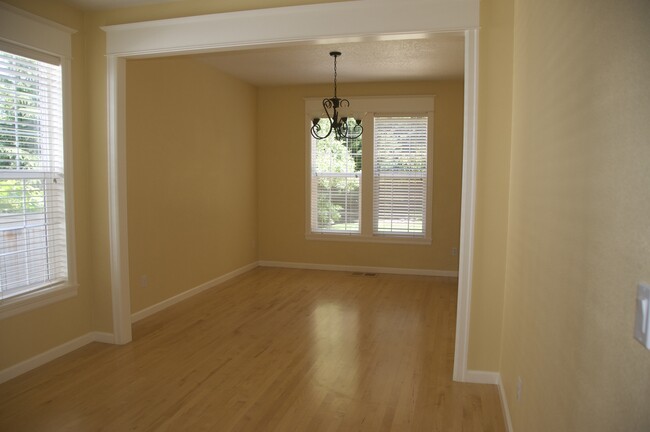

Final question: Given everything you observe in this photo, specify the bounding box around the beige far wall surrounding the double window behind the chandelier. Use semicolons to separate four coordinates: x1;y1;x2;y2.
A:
258;80;463;271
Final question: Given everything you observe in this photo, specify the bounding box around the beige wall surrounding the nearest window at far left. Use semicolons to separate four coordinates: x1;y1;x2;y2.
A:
0;0;92;370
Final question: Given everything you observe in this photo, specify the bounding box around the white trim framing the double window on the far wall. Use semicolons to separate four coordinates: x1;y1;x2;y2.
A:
305;95;435;245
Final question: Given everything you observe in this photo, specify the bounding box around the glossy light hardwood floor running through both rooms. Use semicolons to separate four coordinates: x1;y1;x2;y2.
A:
0;268;505;432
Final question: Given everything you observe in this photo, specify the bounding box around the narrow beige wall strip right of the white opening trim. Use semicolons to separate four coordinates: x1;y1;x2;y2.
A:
467;0;514;371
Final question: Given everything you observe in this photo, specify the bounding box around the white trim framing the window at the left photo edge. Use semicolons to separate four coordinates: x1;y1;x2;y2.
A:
0;2;77;319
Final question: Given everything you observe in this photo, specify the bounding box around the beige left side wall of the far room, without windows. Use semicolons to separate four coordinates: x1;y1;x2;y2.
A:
126;57;257;312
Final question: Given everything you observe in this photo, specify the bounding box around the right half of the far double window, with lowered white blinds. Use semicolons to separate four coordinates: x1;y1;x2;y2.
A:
373;116;429;237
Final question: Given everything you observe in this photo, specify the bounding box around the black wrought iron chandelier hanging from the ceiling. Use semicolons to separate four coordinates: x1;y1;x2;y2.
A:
311;51;363;140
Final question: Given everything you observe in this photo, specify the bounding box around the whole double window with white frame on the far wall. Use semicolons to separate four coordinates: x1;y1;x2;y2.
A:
306;96;433;242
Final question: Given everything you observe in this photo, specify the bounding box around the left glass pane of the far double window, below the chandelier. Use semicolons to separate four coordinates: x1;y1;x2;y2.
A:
311;119;362;233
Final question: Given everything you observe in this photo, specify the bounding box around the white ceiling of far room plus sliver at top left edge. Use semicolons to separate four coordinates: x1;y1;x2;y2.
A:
67;0;464;86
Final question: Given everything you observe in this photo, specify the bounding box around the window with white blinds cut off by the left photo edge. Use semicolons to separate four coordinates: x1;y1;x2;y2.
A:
0;47;68;299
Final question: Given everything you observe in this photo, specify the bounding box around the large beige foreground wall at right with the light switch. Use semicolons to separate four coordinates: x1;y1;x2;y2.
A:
501;0;650;432
